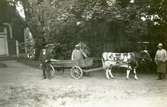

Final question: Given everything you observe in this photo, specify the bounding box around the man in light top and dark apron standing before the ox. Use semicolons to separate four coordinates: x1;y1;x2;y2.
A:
155;43;167;80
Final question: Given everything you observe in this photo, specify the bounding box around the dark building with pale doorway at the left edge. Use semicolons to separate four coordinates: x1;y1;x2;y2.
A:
0;2;25;57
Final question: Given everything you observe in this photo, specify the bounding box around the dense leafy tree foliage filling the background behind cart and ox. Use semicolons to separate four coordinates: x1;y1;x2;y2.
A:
6;0;167;59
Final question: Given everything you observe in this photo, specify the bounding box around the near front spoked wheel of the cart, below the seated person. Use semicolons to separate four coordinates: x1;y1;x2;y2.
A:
70;66;83;79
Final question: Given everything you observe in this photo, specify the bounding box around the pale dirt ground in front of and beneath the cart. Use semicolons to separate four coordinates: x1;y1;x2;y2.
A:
0;60;167;107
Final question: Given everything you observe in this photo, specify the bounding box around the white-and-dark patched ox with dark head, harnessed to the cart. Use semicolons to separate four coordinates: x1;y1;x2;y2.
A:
102;51;151;80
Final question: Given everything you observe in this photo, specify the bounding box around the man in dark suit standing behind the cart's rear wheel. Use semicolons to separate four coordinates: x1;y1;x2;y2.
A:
39;48;50;79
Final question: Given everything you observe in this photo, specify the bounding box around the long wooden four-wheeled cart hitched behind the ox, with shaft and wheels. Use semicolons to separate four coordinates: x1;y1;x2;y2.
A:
49;58;103;79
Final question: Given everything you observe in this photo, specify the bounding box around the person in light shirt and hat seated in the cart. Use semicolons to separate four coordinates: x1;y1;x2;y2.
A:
71;44;87;60
